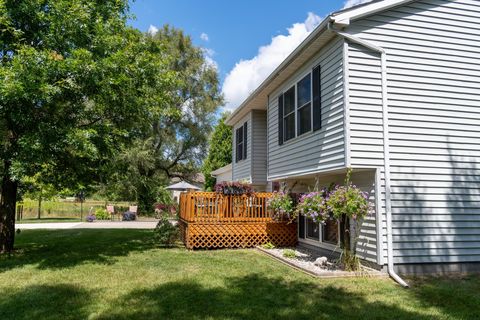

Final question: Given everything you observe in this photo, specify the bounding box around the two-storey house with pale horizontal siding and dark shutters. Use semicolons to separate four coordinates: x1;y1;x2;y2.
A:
227;0;480;273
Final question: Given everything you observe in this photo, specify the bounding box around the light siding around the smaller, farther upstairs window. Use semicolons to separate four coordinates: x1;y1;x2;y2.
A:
232;113;252;182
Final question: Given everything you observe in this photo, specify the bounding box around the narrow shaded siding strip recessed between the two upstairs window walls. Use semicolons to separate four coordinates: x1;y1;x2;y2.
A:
250;110;267;185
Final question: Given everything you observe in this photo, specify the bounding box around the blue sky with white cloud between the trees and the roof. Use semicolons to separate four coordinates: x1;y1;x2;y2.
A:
130;0;364;109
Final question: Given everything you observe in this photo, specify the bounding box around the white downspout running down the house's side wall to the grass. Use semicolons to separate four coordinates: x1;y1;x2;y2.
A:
328;21;408;288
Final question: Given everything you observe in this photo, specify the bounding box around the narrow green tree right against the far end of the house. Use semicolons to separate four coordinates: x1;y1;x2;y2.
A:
202;113;232;190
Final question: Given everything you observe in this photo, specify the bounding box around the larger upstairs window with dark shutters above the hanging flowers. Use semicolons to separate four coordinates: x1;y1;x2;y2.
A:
278;66;322;145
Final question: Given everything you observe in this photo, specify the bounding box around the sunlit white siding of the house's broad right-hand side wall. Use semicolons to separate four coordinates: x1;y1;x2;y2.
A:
347;0;480;263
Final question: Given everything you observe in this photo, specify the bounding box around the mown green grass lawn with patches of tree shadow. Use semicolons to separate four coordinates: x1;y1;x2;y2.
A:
0;229;480;320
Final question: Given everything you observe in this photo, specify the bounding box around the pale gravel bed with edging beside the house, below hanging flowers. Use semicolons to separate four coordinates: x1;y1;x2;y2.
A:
257;247;385;277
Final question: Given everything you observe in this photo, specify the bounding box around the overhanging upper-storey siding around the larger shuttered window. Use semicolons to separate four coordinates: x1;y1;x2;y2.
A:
268;40;345;180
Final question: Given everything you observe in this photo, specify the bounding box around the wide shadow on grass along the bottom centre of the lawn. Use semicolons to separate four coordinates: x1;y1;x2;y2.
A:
95;276;431;320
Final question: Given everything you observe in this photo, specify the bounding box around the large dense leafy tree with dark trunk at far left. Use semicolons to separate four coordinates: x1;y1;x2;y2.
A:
0;0;179;252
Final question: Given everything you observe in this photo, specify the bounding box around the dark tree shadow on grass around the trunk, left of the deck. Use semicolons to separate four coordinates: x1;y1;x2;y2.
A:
0;229;155;272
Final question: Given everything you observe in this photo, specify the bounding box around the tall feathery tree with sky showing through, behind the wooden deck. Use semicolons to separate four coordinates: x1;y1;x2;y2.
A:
100;25;223;213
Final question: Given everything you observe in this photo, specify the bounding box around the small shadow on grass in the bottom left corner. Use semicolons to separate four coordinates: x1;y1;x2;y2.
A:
0;284;91;320
